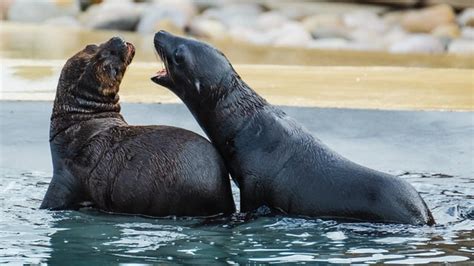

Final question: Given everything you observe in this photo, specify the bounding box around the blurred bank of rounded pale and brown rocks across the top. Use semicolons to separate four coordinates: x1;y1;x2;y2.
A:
0;0;474;61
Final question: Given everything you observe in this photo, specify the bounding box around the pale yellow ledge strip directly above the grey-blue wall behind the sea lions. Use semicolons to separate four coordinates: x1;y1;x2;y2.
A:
0;59;474;111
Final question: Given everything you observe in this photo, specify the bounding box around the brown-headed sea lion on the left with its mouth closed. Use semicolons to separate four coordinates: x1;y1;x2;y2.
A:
41;37;235;216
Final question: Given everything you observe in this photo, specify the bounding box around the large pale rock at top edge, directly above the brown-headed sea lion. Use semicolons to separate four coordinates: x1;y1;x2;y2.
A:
79;1;143;31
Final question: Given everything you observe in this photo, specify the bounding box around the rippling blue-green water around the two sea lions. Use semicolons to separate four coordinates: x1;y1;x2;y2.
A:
0;169;474;265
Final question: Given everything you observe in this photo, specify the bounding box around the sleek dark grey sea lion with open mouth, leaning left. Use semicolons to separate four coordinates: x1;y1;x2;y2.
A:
152;31;434;225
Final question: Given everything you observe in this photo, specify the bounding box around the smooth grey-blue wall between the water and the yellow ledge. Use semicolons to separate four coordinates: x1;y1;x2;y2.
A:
0;101;474;177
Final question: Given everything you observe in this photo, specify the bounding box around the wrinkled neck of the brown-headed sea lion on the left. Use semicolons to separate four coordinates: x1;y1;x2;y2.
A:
50;84;124;139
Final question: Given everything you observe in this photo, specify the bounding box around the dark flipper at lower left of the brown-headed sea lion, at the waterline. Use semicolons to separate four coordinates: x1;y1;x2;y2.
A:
40;170;81;210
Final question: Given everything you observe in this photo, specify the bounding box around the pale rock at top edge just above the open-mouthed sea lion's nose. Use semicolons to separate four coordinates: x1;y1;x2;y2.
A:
137;0;197;33
